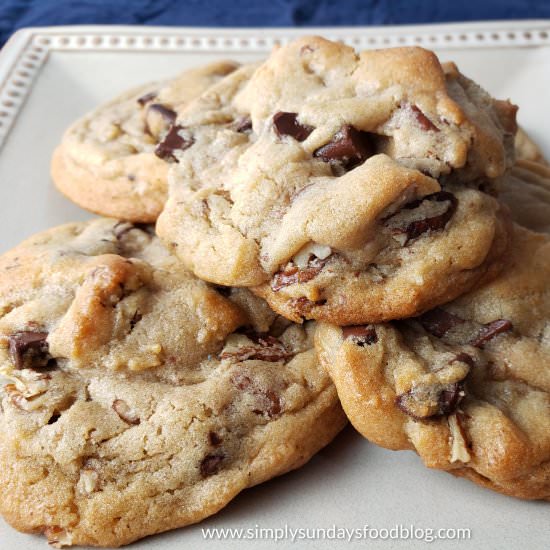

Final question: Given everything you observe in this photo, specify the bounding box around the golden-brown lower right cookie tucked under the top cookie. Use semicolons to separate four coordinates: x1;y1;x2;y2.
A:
316;226;550;500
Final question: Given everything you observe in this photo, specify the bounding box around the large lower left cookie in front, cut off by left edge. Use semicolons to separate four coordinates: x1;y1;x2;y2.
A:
0;219;346;546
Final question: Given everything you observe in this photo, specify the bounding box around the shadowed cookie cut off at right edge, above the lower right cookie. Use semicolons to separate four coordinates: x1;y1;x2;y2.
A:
500;160;550;233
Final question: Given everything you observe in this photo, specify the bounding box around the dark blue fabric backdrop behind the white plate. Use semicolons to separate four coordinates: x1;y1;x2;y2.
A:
0;0;550;44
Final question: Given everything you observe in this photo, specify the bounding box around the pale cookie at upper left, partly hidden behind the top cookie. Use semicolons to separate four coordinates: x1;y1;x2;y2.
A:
51;61;237;222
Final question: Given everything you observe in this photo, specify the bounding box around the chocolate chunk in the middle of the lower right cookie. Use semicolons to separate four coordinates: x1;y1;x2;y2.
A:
395;382;464;420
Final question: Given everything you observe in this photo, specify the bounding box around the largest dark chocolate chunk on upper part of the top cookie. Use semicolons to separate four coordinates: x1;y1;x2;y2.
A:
313;124;373;168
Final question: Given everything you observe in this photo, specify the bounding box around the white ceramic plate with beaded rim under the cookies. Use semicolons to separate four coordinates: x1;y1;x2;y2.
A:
0;21;550;550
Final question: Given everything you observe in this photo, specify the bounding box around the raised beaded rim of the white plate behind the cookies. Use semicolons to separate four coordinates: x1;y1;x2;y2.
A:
0;20;550;149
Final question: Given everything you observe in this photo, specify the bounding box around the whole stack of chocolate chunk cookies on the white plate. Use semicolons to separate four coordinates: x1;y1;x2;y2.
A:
0;37;550;546
